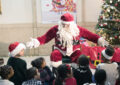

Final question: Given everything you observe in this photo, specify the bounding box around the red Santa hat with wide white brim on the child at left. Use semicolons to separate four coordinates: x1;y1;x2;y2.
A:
8;42;26;57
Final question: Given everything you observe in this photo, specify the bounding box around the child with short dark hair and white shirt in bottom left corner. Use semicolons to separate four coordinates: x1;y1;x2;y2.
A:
0;65;14;85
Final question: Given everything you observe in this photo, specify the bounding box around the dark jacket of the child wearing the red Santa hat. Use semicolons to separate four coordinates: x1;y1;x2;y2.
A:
7;57;27;85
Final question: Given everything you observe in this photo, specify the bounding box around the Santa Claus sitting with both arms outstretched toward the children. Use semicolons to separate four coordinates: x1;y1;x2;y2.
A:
27;13;107;67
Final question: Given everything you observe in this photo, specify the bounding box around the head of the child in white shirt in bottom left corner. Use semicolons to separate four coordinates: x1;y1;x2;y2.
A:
0;65;14;79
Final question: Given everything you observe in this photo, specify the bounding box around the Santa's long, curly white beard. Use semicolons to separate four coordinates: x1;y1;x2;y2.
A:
58;23;79;56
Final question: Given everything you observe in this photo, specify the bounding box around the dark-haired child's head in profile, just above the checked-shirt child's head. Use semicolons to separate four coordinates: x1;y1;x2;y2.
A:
31;57;46;69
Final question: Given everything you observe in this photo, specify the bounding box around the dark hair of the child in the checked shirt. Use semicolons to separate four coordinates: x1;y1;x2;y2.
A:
26;67;37;80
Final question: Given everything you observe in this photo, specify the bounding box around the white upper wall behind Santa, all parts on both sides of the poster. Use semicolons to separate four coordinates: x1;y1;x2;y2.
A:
0;0;102;24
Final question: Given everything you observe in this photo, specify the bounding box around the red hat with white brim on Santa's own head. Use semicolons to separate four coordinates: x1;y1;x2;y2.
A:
61;13;74;24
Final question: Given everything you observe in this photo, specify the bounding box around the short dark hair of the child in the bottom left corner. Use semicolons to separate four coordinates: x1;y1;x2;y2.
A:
0;65;12;79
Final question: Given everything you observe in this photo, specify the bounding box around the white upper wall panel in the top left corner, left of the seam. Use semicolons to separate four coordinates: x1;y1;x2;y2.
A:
0;0;32;24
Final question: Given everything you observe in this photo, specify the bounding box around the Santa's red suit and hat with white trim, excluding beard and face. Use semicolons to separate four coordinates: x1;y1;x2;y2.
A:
27;13;107;67
